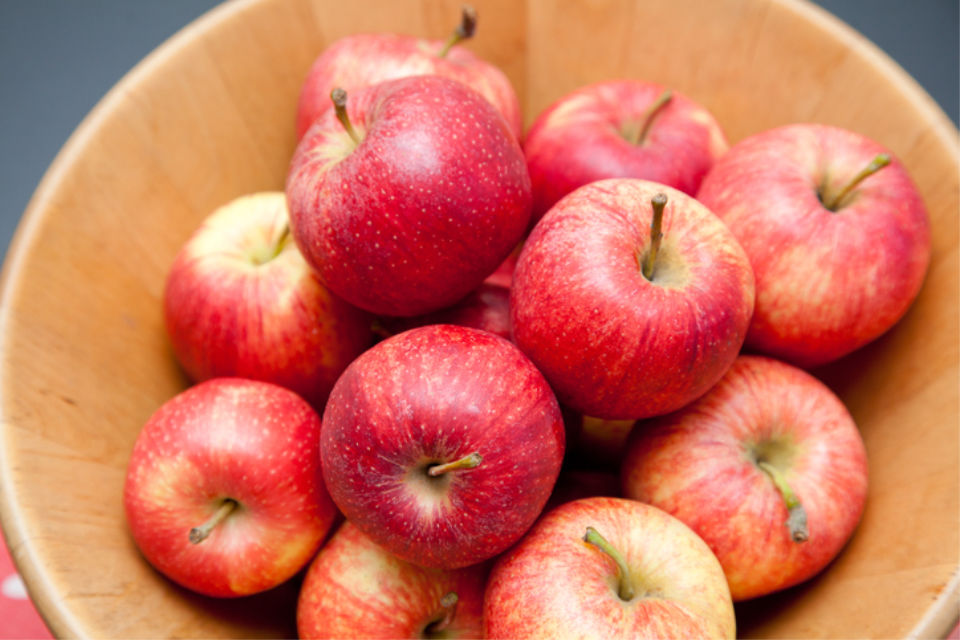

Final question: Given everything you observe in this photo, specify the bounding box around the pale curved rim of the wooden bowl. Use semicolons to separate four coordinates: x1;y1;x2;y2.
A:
0;0;960;638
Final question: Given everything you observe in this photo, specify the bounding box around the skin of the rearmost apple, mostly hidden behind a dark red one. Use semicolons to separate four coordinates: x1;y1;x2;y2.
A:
297;33;523;140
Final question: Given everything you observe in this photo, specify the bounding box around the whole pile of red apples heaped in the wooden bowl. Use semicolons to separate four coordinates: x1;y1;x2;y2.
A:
125;8;930;638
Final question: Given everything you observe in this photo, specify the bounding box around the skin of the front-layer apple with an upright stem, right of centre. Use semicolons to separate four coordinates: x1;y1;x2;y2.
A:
510;178;753;420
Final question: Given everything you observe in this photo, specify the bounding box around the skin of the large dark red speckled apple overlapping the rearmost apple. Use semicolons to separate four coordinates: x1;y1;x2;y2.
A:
287;76;530;316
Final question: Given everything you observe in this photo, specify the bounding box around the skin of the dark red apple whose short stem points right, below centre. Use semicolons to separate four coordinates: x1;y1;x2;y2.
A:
321;325;564;569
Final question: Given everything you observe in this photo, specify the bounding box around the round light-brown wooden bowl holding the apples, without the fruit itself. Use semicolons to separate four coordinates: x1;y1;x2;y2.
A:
0;0;960;638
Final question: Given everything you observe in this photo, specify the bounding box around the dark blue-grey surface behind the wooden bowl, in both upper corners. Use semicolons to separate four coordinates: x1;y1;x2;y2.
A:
0;0;960;264
